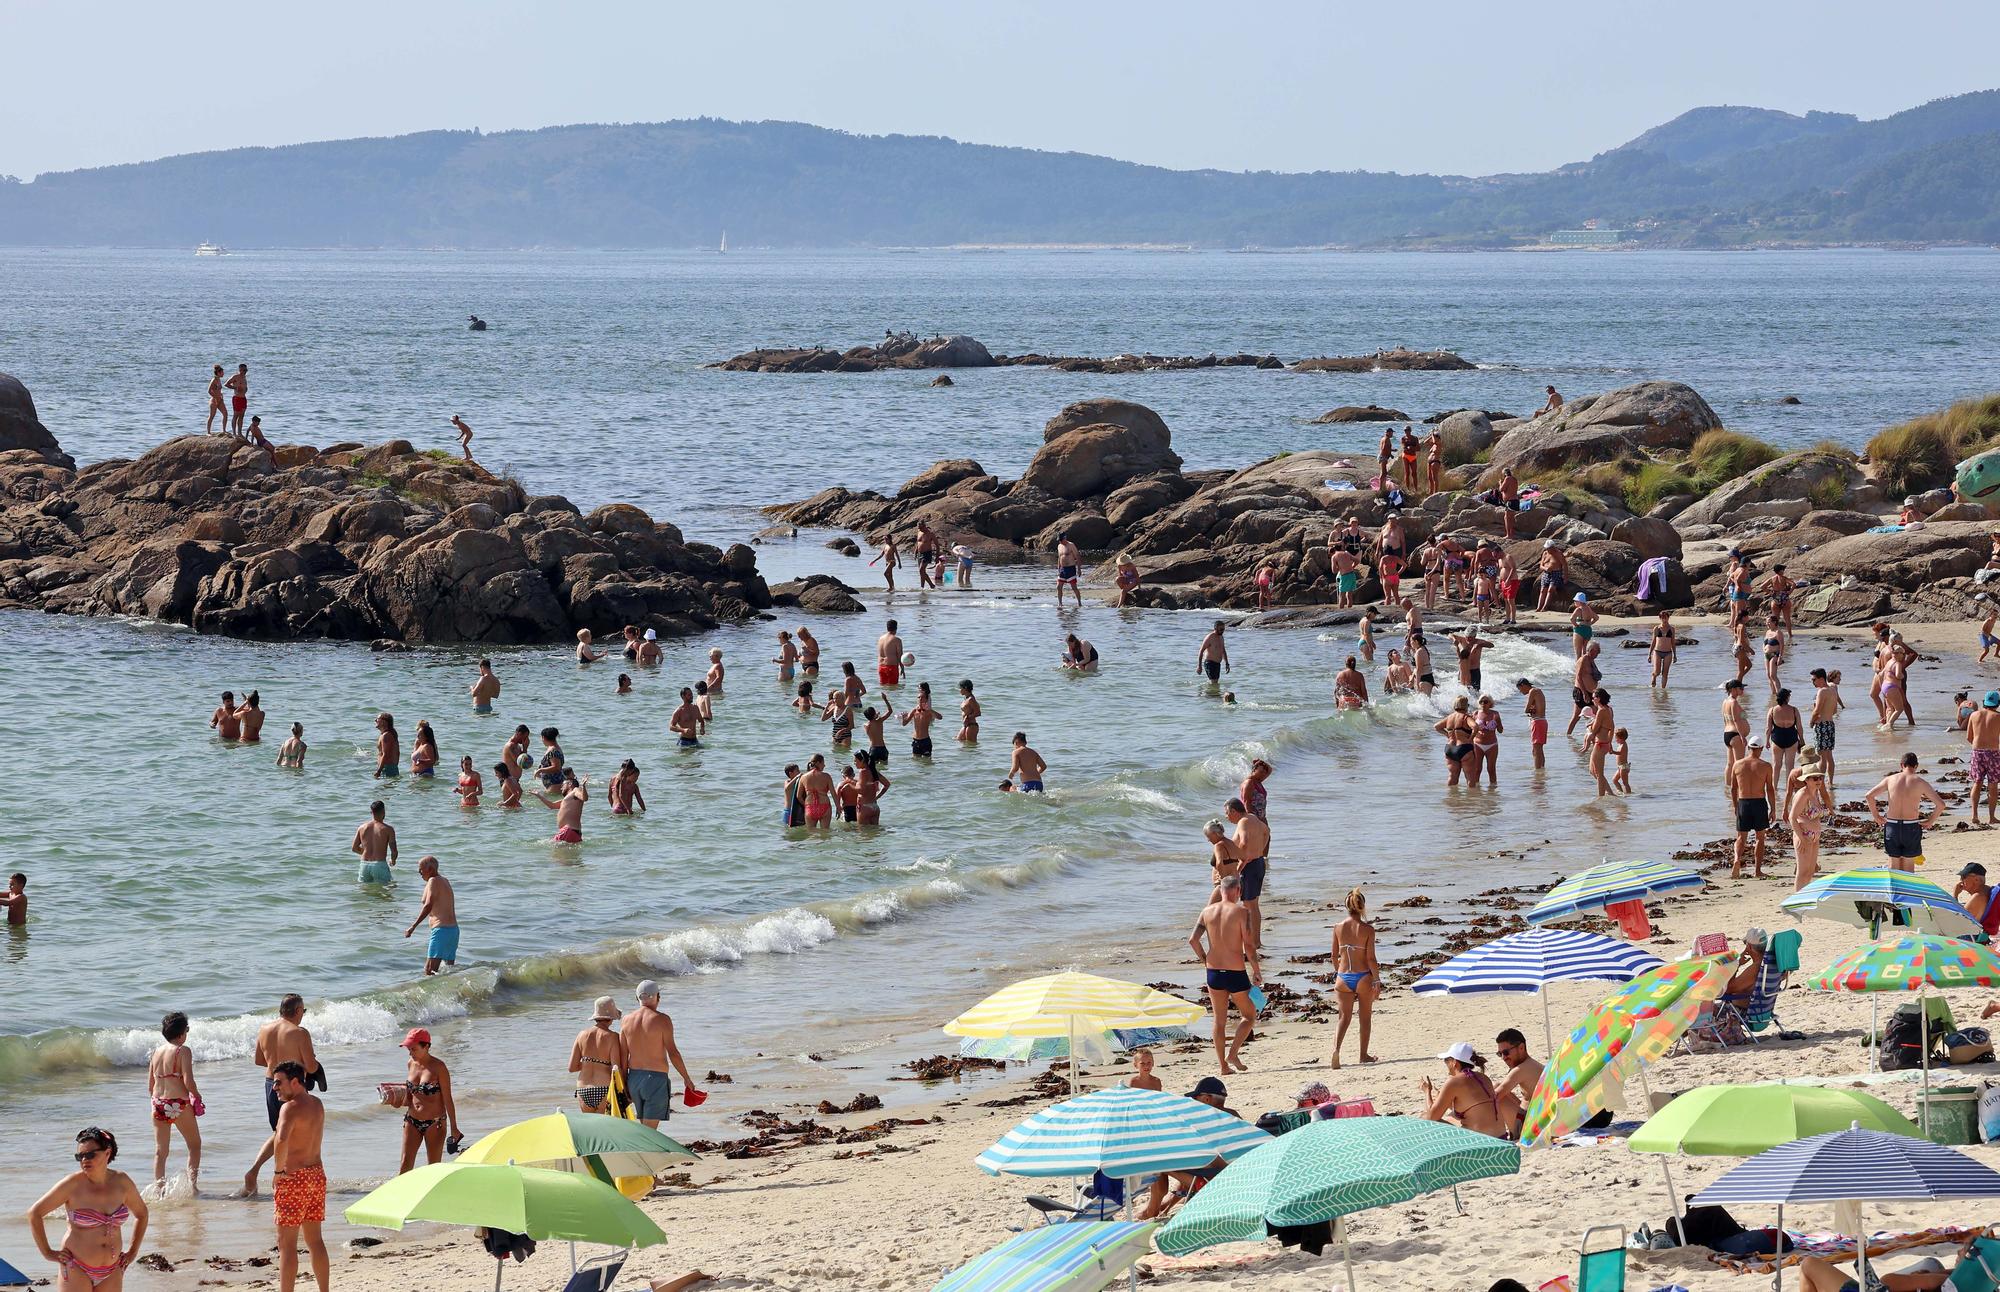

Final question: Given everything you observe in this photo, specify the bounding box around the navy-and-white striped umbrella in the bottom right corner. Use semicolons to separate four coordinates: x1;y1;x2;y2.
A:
1694;1126;2000;1288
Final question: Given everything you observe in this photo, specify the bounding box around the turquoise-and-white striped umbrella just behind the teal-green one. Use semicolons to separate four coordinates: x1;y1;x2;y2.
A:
976;1086;1270;1180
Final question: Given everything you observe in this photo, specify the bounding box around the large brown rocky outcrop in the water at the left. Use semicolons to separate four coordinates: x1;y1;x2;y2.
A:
0;390;770;642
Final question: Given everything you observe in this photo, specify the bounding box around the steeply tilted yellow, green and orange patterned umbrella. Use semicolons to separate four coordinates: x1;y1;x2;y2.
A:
1520;956;1736;1148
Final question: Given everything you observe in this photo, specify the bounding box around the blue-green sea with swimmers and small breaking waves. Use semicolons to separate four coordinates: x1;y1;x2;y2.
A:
0;250;2000;1286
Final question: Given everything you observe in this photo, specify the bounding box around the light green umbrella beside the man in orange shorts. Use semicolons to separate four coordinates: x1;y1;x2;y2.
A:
346;1162;666;1288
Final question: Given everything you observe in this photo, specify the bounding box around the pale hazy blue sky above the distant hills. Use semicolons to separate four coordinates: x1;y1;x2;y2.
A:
0;0;2000;178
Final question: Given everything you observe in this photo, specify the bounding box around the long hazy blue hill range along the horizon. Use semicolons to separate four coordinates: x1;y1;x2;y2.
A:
0;90;2000;248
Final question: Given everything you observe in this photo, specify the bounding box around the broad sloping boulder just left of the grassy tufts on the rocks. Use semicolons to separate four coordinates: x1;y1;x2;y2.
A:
1486;382;1722;482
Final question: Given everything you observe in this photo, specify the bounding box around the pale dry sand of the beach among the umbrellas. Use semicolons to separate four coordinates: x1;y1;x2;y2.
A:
156;628;2000;1292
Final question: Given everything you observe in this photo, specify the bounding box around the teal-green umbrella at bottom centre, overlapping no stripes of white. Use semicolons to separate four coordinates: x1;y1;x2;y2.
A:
1156;1118;1520;1288
